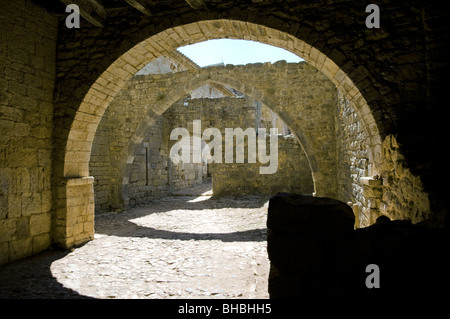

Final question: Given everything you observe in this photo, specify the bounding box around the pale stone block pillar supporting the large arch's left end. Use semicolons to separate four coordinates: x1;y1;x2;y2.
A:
53;176;95;249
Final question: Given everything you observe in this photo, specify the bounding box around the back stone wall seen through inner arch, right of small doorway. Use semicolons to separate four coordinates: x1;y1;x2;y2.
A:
170;98;314;196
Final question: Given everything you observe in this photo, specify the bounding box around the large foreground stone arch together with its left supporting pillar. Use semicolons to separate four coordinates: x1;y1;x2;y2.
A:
53;19;381;247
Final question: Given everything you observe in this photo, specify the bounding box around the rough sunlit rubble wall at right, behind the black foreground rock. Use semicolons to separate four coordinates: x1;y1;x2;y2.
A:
336;90;431;227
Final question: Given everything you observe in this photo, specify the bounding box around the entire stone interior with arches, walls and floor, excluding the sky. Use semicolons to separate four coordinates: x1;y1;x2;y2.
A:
0;0;450;299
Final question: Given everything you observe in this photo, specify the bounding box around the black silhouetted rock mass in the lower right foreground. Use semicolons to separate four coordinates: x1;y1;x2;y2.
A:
267;194;450;298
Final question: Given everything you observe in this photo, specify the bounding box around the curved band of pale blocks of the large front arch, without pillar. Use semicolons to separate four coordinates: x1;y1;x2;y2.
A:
64;20;381;178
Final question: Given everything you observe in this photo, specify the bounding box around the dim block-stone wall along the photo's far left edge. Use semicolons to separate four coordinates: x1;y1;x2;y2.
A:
0;1;57;264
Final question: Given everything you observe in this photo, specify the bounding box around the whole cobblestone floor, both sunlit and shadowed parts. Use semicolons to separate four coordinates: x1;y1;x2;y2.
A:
0;184;269;298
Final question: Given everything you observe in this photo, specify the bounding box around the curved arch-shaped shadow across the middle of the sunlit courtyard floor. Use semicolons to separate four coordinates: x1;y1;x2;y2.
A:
95;183;270;242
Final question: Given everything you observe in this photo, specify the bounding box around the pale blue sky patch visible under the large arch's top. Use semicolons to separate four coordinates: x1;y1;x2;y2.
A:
178;39;303;67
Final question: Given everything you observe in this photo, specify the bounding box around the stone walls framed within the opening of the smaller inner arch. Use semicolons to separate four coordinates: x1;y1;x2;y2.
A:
122;91;314;209
